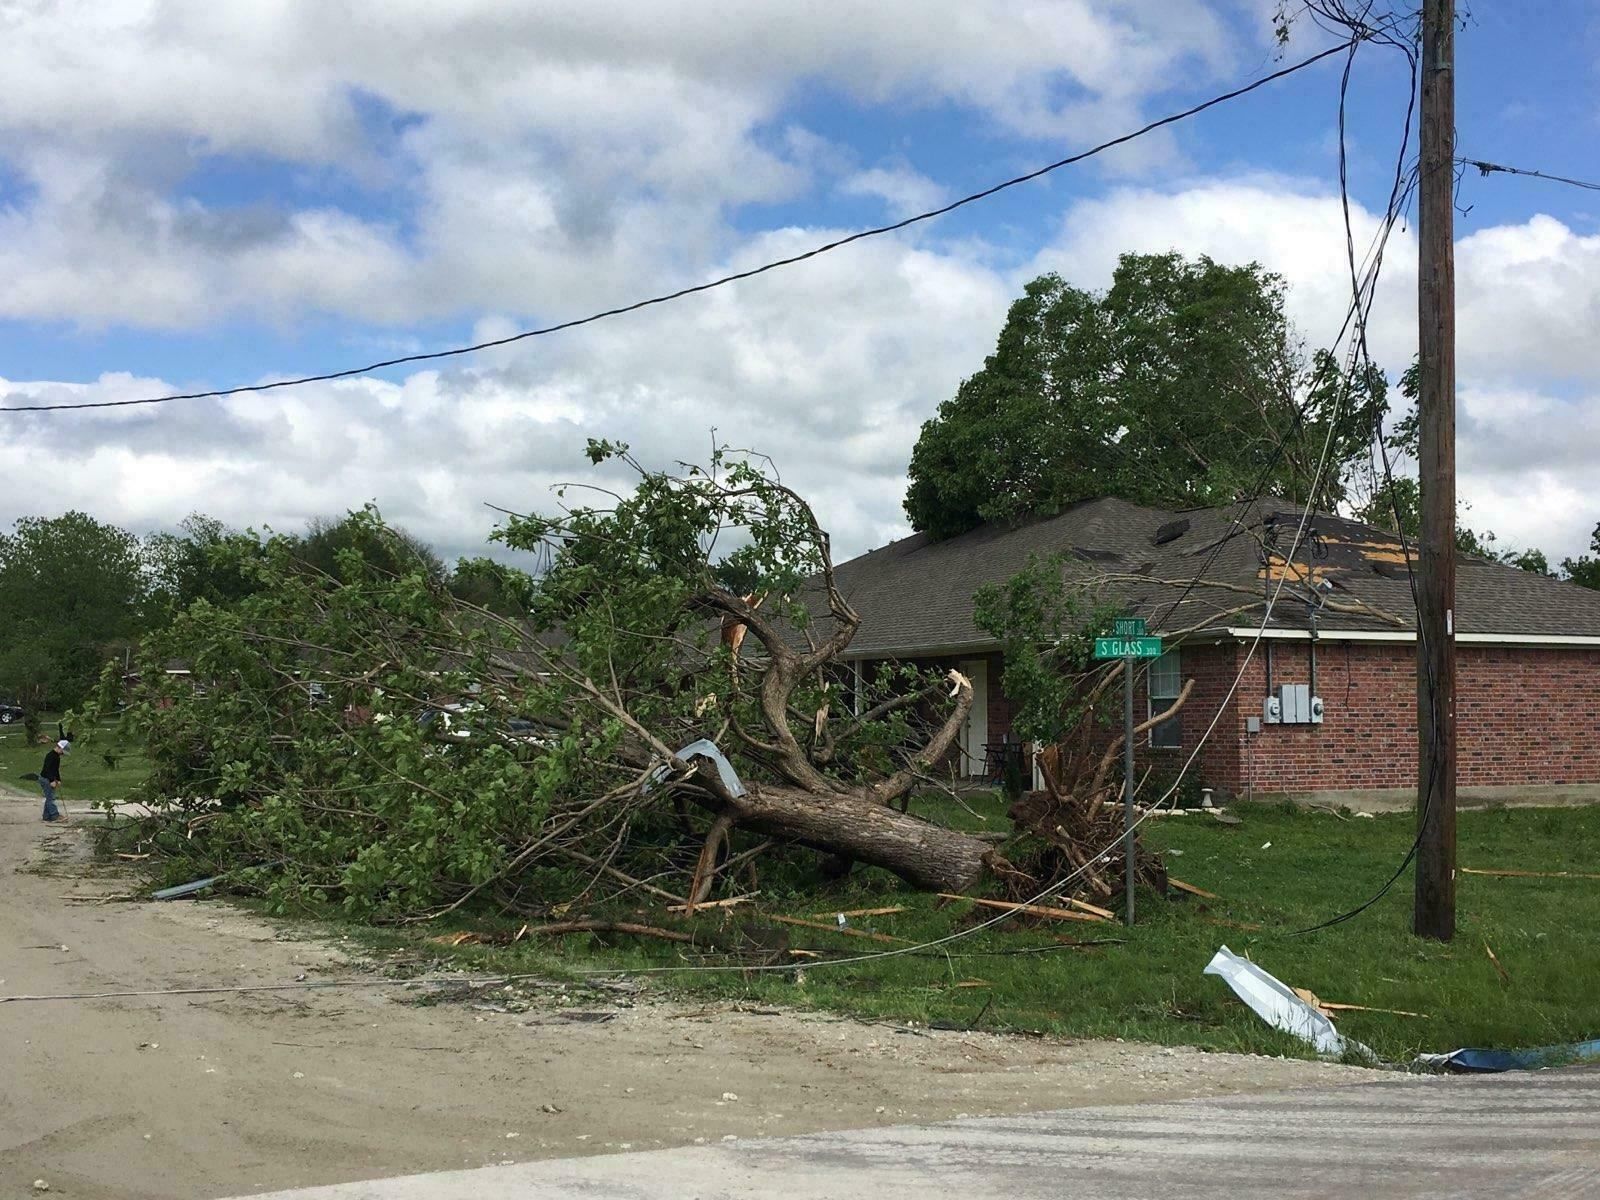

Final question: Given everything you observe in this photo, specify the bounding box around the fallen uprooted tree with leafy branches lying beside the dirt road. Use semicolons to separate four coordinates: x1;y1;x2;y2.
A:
104;443;1006;918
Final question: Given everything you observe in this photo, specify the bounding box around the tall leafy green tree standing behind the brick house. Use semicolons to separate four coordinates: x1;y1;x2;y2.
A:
906;253;1386;538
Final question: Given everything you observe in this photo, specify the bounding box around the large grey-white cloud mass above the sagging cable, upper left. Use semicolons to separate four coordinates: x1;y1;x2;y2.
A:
0;0;1235;330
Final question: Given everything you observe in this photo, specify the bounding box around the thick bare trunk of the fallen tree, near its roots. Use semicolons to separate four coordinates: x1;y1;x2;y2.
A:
736;786;994;891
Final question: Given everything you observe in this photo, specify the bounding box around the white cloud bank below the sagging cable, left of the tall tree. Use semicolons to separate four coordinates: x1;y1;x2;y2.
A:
0;229;1010;566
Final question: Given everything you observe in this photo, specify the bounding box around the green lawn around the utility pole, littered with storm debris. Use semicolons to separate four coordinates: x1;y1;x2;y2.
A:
350;802;1600;1059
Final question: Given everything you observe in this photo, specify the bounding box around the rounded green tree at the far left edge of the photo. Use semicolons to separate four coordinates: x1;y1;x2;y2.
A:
0;512;144;707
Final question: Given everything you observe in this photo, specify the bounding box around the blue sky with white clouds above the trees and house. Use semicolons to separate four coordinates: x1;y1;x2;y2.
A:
0;0;1600;562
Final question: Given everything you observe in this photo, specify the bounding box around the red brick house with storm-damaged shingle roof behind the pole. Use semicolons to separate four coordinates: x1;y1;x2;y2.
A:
837;499;1600;806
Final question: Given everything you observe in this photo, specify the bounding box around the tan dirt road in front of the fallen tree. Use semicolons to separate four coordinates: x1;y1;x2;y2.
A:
0;794;1366;1200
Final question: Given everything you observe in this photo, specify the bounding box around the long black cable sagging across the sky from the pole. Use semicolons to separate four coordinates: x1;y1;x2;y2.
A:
0;32;1365;413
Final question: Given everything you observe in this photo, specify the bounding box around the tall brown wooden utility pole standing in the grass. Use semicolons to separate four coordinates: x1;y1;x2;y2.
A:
1411;0;1456;941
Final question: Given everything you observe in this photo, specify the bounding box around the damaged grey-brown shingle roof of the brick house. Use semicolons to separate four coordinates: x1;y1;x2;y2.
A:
837;499;1600;658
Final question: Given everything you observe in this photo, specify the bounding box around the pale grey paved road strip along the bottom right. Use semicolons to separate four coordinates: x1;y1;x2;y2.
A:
240;1069;1600;1200
